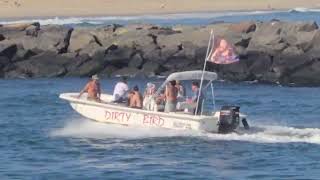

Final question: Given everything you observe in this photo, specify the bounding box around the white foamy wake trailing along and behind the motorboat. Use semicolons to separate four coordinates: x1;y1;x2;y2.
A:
50;119;320;144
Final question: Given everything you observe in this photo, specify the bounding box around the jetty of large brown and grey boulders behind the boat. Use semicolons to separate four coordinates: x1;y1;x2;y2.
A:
0;20;320;86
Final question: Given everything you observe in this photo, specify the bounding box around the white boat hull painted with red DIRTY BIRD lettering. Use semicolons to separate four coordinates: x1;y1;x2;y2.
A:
60;93;219;133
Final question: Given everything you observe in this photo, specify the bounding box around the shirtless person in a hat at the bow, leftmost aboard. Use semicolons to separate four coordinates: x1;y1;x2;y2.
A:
78;75;101;102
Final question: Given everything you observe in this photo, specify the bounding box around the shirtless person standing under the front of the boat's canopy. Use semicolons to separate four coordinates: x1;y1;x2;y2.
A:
164;80;178;112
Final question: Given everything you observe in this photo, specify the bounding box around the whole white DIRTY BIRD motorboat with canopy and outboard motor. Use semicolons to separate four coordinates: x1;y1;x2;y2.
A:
60;71;249;133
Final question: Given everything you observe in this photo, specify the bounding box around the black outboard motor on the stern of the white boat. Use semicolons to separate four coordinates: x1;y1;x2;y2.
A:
218;106;240;134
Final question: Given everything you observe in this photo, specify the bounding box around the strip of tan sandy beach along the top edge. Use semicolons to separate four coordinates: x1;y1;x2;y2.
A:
0;0;320;18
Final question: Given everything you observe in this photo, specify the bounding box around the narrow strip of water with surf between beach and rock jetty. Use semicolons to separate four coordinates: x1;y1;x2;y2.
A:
0;8;320;27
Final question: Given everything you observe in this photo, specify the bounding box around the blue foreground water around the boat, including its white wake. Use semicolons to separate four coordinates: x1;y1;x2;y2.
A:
0;78;320;180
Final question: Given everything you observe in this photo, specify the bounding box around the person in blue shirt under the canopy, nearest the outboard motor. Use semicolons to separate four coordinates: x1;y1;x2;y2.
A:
187;81;203;114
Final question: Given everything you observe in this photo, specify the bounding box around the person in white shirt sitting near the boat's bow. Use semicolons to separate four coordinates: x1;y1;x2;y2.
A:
113;77;129;103
